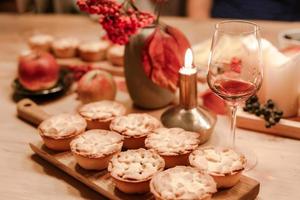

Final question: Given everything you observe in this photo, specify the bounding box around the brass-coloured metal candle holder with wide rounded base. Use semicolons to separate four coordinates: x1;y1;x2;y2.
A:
161;59;216;144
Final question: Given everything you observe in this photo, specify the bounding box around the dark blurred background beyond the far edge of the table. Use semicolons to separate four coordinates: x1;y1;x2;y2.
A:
0;0;300;21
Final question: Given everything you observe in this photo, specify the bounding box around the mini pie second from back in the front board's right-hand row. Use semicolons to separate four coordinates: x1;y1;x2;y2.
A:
110;113;161;149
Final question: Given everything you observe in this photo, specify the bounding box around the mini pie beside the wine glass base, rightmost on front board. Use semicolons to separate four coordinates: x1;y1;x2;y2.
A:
189;147;246;188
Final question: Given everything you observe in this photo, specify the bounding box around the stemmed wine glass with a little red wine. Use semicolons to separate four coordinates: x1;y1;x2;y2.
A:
207;20;263;169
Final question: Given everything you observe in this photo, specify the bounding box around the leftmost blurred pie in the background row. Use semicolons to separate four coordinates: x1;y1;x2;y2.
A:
28;34;53;52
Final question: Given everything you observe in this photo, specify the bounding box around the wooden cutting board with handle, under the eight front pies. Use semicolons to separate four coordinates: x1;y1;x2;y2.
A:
17;99;260;200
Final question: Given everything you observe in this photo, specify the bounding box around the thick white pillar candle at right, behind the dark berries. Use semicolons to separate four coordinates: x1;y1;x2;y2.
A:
259;40;300;117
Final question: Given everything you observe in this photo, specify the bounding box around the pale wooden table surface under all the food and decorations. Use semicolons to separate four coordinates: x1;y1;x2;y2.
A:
0;14;300;200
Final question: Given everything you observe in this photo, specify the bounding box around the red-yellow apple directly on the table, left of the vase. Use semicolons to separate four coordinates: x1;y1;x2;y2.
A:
77;69;117;103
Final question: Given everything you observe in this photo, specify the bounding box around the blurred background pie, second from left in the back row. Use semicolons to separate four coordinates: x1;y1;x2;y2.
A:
52;37;79;58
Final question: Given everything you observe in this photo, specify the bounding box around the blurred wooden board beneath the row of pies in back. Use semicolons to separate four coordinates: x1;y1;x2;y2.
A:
56;58;124;76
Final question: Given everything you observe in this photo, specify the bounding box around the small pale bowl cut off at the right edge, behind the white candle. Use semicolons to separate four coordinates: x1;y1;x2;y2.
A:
278;29;300;49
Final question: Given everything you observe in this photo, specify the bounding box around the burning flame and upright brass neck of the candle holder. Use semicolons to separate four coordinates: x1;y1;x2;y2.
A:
179;49;197;109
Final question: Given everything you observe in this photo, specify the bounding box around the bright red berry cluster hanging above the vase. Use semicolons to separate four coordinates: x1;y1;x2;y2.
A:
77;0;154;45
